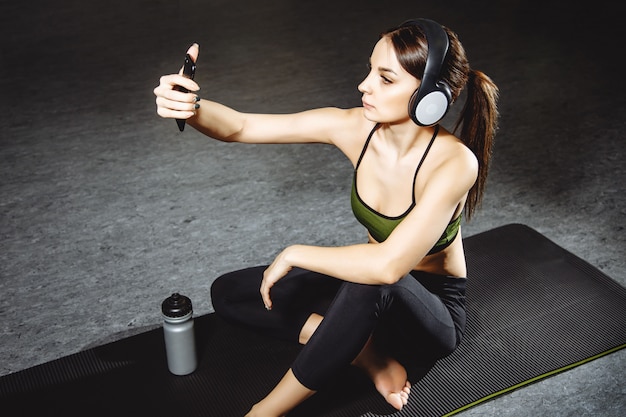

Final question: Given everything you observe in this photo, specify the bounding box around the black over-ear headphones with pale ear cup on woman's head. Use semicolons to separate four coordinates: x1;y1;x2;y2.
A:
400;19;452;126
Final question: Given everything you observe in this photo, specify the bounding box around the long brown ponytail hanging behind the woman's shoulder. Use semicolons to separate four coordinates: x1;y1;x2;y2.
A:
454;69;498;220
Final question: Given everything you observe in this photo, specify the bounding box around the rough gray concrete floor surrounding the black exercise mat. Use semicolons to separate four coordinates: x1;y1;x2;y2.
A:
0;0;626;417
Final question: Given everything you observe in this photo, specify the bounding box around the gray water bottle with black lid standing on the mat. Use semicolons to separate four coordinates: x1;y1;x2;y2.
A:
161;293;198;375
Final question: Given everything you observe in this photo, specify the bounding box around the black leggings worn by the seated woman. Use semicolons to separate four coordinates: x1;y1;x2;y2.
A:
211;266;466;390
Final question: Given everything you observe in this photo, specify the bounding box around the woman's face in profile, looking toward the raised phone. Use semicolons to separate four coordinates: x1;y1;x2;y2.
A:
359;37;420;123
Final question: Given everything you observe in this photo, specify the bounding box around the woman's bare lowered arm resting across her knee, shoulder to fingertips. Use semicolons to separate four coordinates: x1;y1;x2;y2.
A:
260;143;477;308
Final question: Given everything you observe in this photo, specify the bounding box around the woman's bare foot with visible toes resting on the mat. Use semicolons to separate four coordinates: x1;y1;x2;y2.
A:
353;343;411;410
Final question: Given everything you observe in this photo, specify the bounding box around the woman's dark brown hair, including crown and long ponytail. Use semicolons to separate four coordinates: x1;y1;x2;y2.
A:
381;25;498;220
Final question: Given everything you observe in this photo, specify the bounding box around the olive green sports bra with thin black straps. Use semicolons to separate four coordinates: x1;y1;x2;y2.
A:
350;125;461;255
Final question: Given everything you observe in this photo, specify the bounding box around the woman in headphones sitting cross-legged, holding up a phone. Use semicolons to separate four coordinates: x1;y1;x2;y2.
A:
154;19;498;417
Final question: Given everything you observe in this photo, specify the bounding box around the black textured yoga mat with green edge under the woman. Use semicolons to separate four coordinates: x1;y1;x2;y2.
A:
0;224;626;417
